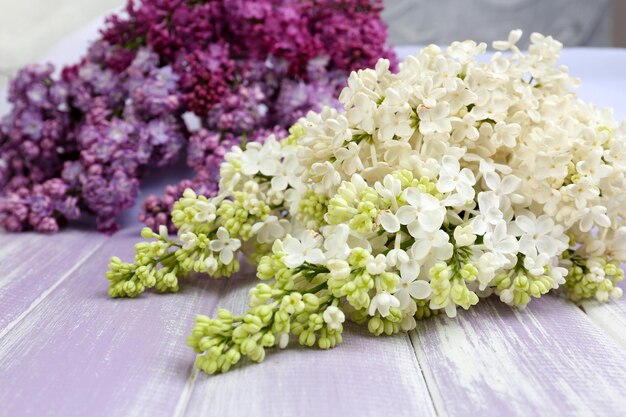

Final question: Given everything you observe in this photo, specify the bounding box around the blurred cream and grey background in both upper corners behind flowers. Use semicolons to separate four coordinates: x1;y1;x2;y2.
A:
0;0;626;79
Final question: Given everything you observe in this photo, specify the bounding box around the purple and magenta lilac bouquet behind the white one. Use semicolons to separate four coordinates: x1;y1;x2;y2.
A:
0;0;393;232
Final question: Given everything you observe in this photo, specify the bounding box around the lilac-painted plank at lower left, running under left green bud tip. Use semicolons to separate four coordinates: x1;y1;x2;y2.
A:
0;228;223;417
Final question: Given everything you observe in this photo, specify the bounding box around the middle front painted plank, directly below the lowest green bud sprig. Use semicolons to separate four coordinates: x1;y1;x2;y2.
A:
181;264;436;417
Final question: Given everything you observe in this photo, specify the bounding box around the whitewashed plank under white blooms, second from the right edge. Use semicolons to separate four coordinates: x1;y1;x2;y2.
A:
411;297;626;416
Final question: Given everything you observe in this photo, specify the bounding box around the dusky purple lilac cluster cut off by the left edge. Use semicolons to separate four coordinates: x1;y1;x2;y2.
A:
0;65;78;232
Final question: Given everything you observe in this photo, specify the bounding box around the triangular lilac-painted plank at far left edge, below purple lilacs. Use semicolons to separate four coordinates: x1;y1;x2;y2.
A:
0;230;106;337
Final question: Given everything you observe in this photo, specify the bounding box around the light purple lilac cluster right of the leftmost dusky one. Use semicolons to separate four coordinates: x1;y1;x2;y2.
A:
62;46;186;232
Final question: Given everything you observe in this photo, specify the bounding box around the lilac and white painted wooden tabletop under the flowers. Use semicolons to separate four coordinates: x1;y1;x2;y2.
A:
0;22;626;417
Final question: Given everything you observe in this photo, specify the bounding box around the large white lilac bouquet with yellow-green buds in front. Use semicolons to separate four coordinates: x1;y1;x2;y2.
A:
107;31;626;373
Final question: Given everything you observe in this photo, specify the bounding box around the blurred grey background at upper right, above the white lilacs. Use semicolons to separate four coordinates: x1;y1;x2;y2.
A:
384;0;626;46
